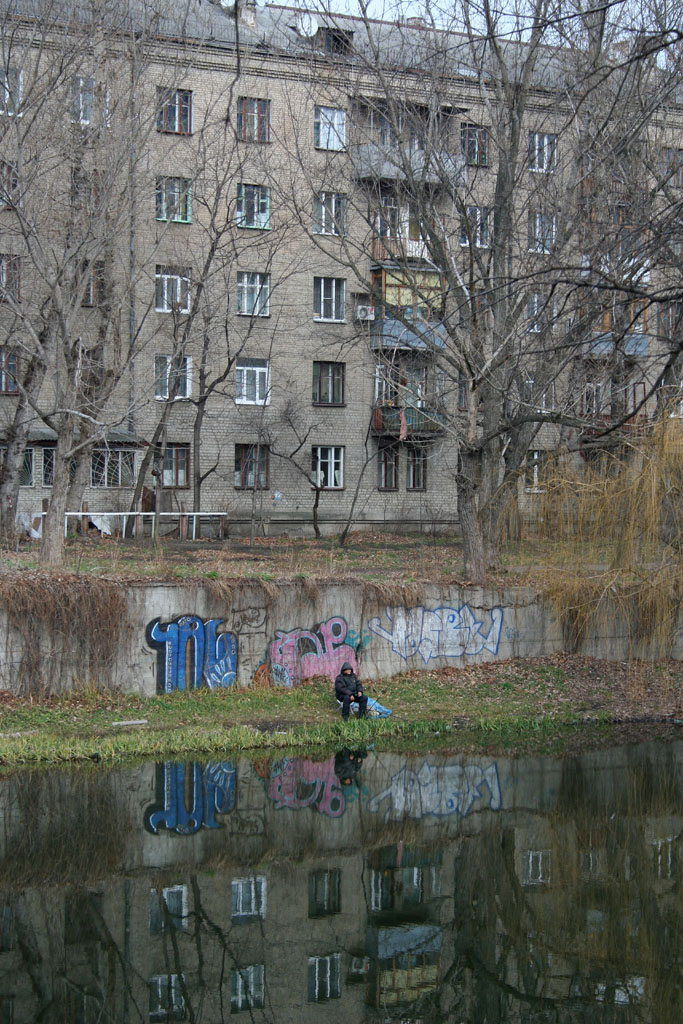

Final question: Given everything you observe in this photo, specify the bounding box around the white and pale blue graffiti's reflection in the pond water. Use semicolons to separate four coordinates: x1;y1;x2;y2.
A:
368;761;503;821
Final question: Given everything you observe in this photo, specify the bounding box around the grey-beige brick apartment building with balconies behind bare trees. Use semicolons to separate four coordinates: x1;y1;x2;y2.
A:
0;0;683;531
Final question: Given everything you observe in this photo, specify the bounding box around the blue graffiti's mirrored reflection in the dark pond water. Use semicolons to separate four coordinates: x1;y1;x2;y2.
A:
144;761;236;836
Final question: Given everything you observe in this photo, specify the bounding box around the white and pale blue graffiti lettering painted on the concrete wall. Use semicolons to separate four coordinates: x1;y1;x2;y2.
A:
368;604;503;663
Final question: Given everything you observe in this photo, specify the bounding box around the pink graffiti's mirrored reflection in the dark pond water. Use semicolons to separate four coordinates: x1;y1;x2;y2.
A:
266;757;346;818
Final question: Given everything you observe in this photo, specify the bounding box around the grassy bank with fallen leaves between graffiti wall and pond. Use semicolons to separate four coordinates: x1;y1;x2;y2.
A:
0;655;683;769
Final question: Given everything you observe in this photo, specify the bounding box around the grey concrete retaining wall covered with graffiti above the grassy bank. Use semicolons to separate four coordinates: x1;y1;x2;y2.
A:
0;584;683;694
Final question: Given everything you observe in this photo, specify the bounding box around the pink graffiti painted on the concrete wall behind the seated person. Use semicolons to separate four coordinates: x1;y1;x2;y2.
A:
270;616;357;686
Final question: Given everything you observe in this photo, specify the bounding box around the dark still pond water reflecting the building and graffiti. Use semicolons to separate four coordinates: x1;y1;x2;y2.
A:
0;741;683;1024
